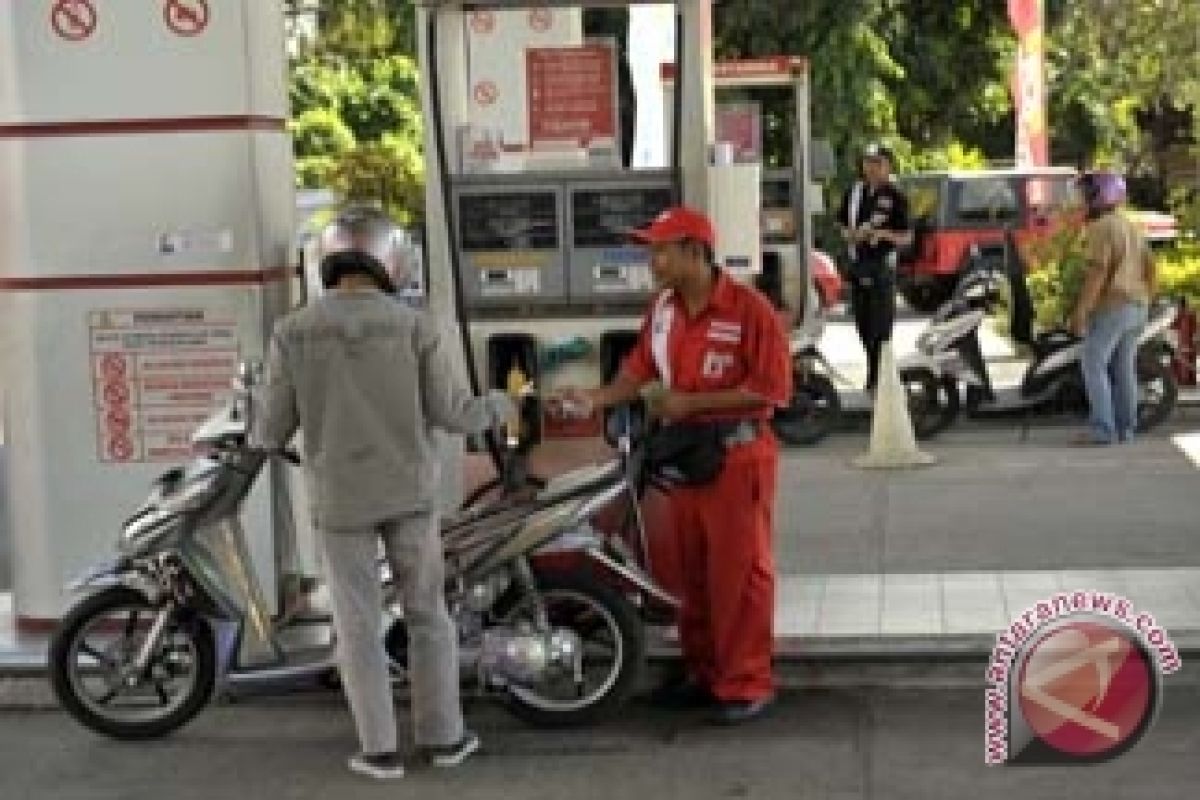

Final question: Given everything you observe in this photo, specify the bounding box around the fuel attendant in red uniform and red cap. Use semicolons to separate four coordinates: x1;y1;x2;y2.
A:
552;206;792;724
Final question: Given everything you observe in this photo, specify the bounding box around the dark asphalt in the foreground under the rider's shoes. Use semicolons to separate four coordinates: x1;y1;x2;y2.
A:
0;685;1200;800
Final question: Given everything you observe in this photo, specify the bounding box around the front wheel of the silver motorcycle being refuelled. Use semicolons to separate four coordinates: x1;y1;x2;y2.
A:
49;587;216;740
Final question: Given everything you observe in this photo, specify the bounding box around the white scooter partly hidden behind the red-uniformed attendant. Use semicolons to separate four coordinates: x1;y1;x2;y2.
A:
772;318;848;445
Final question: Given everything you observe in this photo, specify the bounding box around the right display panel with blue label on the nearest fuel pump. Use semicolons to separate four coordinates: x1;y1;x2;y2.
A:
569;182;673;302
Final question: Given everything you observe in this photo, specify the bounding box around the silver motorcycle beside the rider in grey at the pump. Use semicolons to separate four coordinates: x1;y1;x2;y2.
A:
49;369;677;739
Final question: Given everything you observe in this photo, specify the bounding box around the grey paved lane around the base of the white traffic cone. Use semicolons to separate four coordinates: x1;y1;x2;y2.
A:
776;409;1200;573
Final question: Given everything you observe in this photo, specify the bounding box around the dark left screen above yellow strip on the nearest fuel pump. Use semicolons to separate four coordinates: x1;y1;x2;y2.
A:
458;192;558;251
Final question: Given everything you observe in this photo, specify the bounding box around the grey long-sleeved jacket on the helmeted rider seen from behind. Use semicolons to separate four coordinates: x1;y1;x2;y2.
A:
253;291;506;530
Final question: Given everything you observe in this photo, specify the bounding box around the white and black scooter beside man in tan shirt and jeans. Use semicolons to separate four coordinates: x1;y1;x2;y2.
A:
898;237;1178;438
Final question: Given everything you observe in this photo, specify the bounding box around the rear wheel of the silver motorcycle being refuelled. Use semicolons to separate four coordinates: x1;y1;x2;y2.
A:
505;572;646;728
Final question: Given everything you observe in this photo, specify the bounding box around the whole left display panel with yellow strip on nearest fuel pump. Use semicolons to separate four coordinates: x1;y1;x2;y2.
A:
456;185;566;309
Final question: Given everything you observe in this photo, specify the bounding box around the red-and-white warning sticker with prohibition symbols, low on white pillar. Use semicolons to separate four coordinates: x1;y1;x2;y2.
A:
88;308;240;464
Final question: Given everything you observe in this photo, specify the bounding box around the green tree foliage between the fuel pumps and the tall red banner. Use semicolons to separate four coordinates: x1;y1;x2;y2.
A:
715;0;1013;185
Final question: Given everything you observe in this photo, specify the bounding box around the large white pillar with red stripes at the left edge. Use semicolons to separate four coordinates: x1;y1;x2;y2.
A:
0;0;294;624
